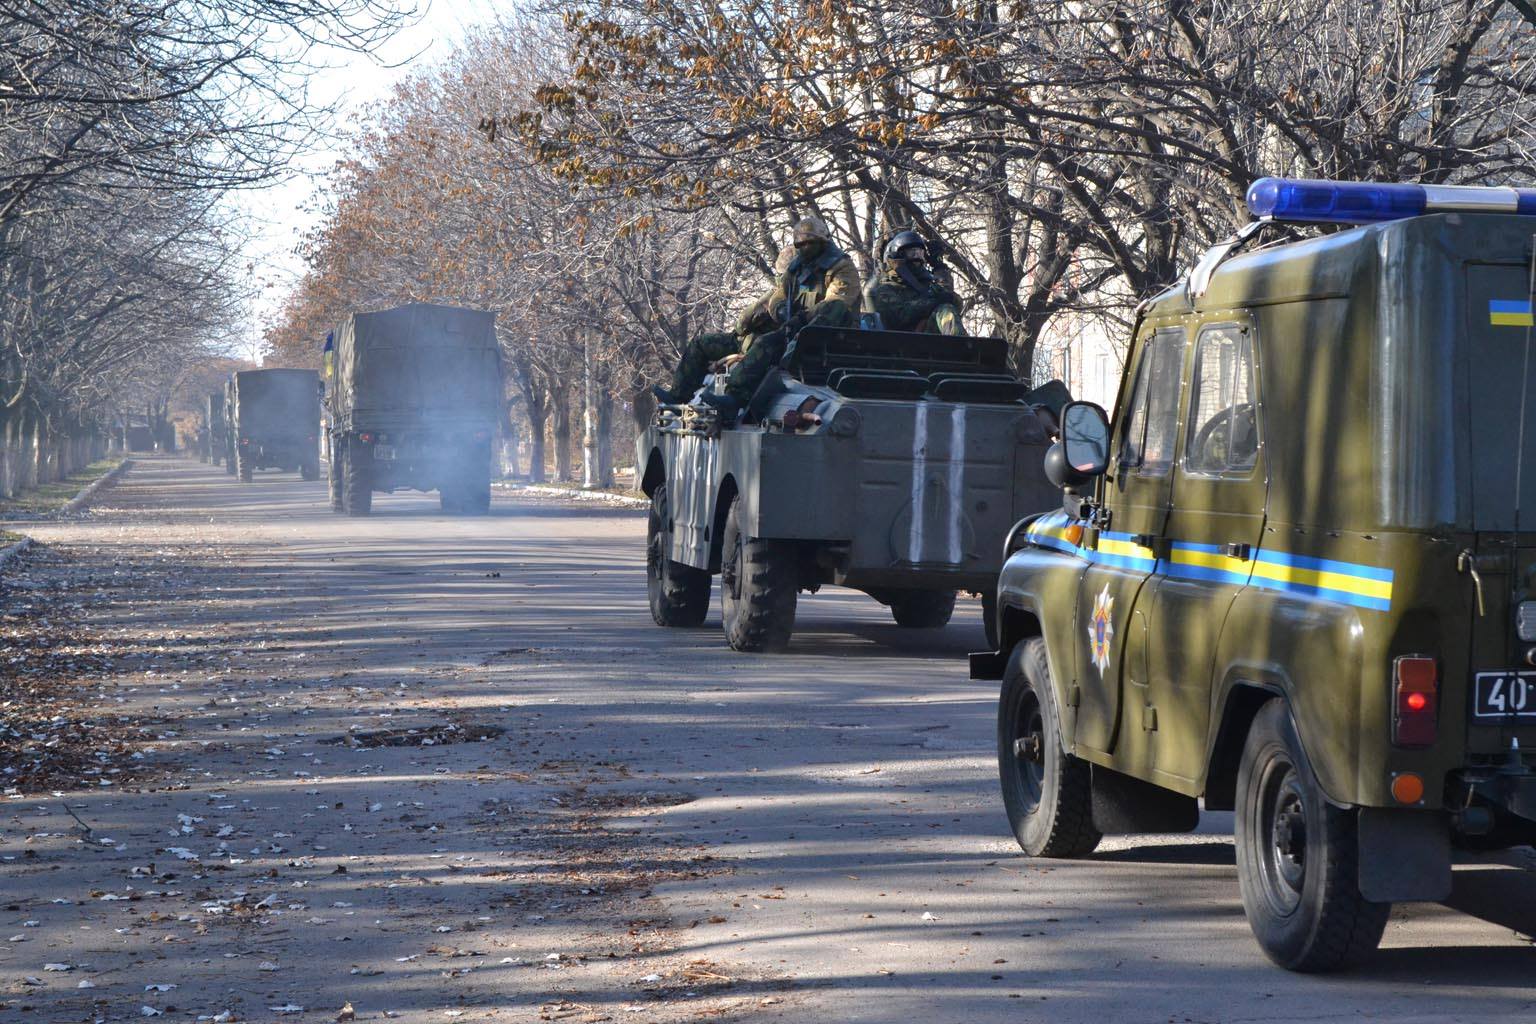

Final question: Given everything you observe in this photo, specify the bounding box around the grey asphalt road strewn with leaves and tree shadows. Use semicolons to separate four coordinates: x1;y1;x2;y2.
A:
0;459;1536;1024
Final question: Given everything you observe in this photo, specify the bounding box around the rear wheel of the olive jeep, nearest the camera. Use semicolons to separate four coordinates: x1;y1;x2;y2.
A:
1236;700;1392;972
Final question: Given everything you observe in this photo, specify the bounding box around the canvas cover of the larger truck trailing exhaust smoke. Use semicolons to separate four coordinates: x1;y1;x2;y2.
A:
336;302;502;425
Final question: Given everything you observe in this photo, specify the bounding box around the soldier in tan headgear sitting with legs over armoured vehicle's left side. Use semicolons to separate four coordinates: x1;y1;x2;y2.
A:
653;216;859;419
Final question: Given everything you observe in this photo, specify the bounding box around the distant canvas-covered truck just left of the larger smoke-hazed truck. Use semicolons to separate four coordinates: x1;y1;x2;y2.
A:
227;370;319;484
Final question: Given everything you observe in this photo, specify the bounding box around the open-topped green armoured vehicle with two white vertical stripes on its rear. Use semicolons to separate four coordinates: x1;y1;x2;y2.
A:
636;327;1060;651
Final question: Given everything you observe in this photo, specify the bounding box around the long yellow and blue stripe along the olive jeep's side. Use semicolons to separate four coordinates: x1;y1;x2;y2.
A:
1025;513;1393;611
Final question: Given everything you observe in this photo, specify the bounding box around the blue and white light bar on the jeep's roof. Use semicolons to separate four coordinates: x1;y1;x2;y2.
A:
1247;178;1536;224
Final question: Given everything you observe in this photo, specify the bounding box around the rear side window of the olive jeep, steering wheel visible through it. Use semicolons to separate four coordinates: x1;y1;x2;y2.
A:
1184;324;1258;476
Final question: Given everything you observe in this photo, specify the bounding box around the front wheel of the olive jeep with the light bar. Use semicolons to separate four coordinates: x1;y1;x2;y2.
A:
997;637;1103;857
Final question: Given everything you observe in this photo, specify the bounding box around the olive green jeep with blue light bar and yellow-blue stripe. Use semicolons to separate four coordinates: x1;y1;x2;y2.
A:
972;180;1536;970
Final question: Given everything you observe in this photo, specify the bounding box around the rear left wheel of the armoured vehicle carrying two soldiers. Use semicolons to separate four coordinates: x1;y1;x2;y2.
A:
720;497;800;651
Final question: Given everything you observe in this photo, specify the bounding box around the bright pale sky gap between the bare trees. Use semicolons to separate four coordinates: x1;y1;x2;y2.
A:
232;0;513;359
